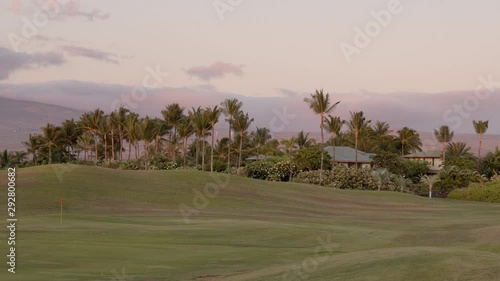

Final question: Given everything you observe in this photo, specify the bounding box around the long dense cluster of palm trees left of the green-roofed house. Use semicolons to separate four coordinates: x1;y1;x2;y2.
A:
12;98;266;171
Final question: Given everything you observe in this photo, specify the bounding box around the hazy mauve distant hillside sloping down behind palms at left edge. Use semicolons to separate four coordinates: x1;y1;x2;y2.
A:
0;97;82;150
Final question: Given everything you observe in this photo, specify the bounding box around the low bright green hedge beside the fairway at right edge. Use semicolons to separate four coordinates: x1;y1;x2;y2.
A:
448;181;500;203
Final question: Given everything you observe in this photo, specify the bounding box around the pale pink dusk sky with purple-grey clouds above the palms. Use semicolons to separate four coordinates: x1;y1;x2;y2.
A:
0;0;500;134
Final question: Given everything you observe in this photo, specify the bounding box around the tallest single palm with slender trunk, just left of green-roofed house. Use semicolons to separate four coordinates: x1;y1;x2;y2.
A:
304;89;340;185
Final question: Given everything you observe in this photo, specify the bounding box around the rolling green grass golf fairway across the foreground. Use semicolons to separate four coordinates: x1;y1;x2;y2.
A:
0;165;500;281
